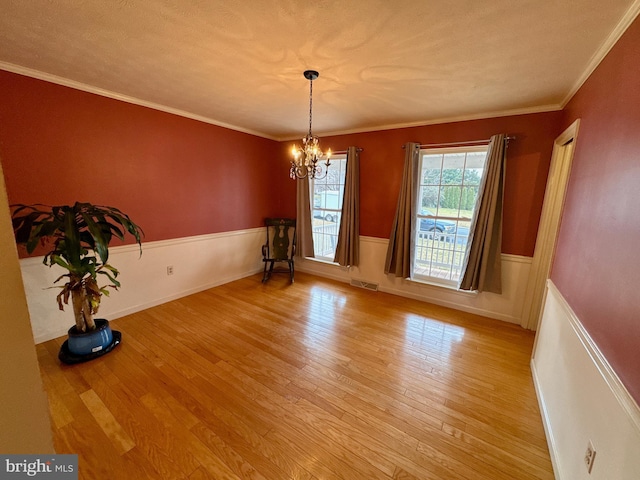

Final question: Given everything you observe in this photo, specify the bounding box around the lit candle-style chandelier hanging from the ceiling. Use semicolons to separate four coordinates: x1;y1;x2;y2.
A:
289;70;331;180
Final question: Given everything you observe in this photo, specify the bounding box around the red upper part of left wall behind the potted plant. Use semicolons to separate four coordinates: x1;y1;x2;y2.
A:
0;71;286;248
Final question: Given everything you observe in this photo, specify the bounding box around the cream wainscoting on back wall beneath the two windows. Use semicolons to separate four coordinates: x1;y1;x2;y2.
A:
296;237;532;324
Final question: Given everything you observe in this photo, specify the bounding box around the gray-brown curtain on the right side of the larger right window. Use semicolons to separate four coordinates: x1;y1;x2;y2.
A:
459;134;507;293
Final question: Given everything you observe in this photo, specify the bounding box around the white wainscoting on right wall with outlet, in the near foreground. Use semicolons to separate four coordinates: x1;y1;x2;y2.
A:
531;281;640;480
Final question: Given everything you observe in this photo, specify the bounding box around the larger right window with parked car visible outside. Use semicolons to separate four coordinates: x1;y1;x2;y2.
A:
413;146;487;287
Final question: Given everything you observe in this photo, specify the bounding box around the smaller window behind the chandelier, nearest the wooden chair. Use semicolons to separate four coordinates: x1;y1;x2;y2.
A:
310;155;347;262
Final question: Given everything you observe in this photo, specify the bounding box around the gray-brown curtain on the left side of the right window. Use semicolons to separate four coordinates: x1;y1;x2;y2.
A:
384;143;420;278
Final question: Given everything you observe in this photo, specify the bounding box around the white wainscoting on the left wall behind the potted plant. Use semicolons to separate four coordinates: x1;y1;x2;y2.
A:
20;228;265;343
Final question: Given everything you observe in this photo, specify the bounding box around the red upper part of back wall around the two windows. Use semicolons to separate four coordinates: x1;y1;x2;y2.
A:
281;112;562;256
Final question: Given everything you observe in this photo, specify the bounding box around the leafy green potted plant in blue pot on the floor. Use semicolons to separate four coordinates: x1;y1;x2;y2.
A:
12;202;143;363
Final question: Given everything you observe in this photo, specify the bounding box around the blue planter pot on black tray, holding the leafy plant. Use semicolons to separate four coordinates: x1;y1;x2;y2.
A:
58;318;122;364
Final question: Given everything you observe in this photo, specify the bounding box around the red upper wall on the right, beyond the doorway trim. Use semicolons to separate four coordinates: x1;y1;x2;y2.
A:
551;15;640;403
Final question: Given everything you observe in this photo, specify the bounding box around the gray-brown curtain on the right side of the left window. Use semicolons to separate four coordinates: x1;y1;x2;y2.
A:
333;147;360;267
